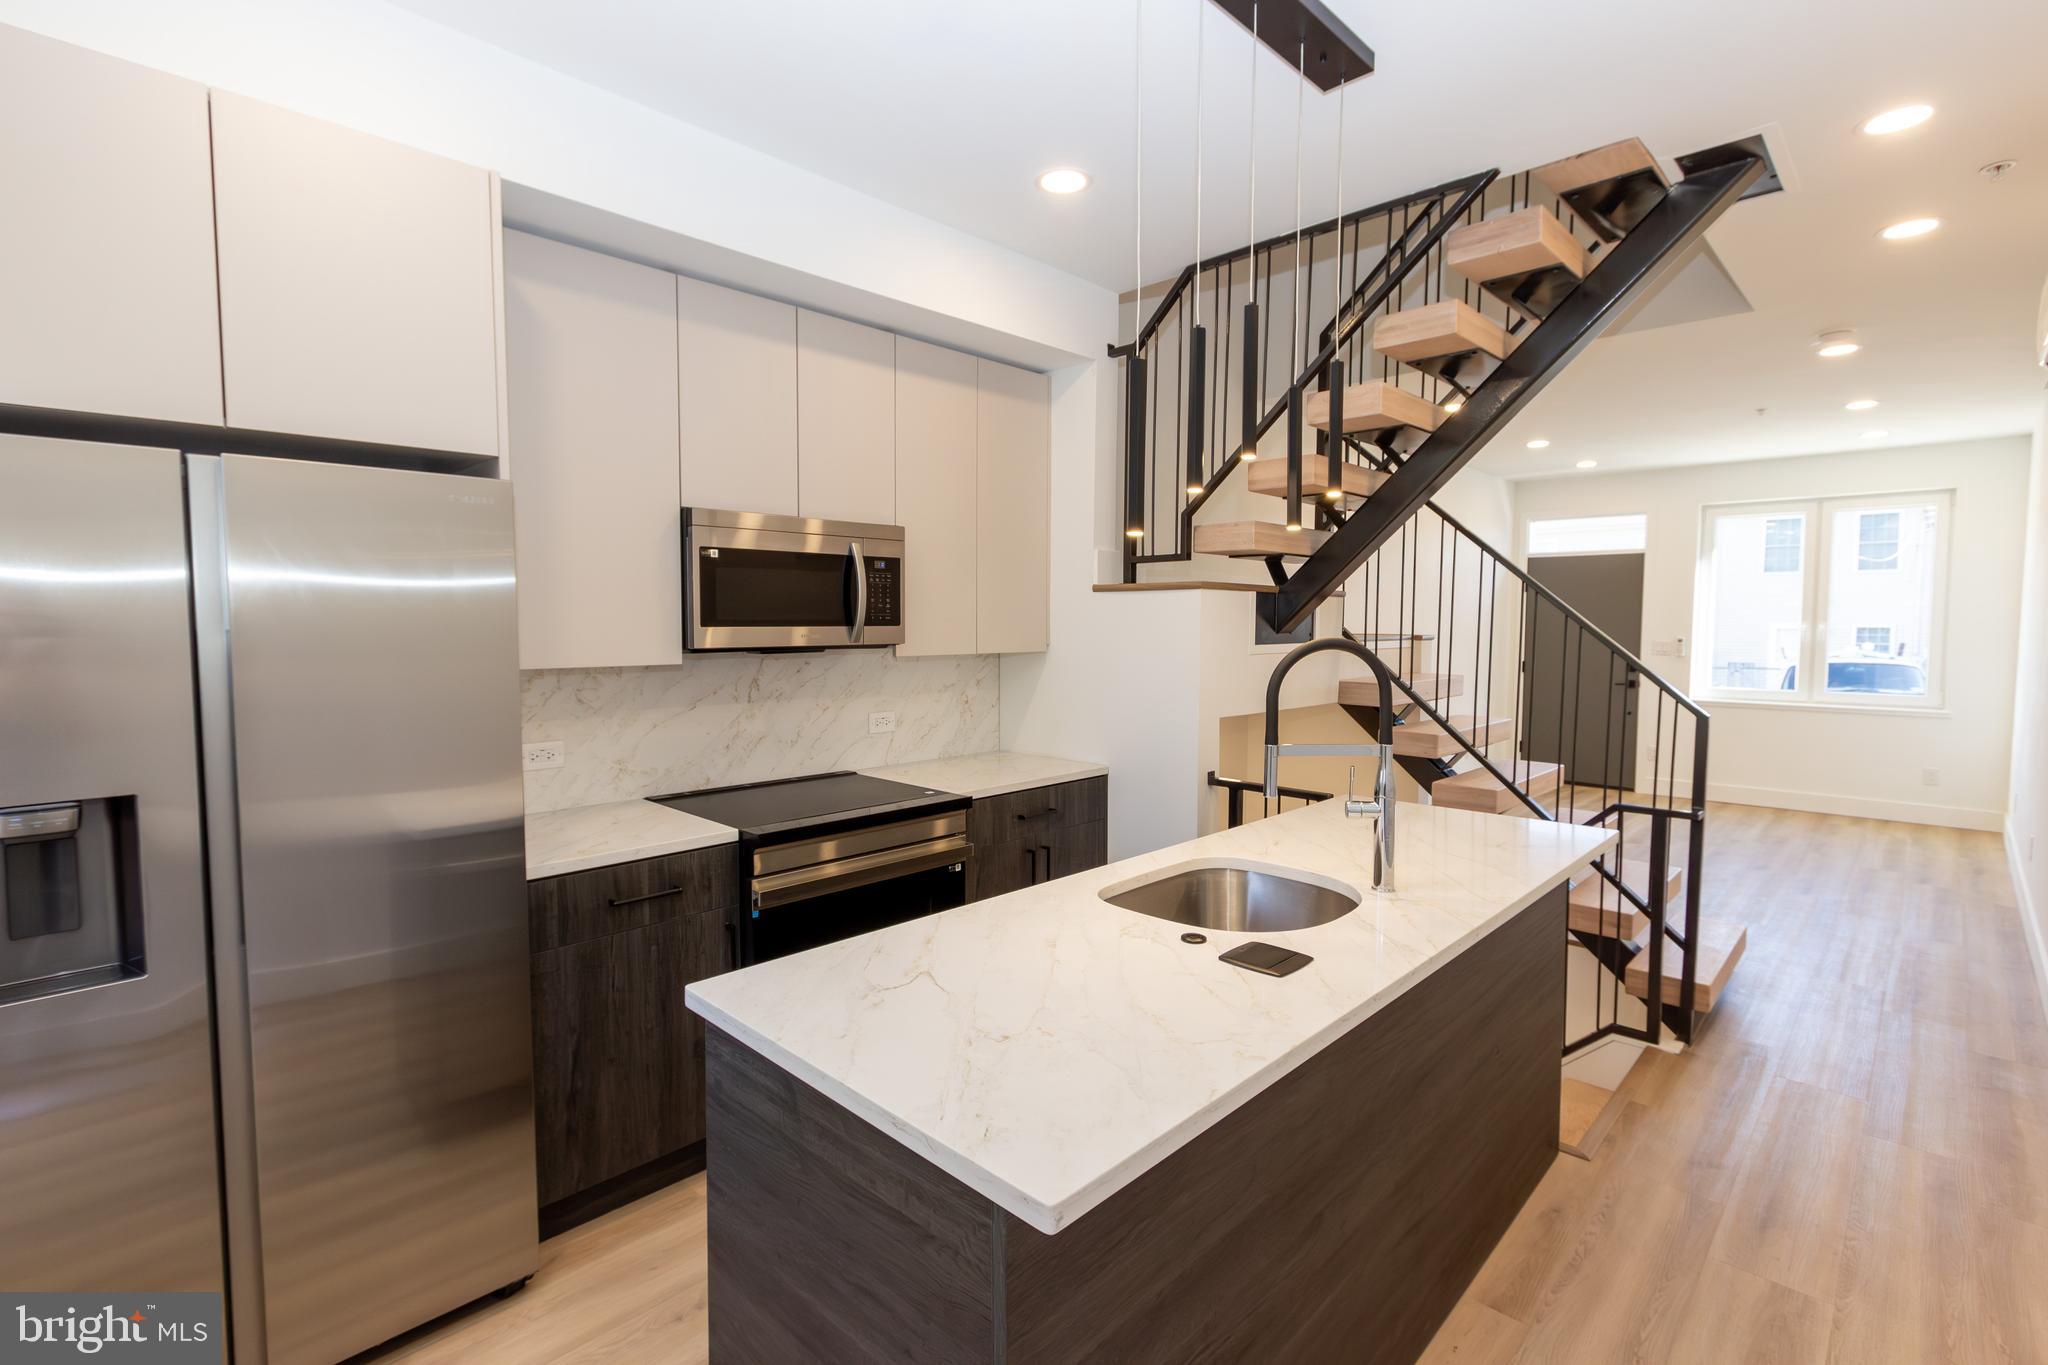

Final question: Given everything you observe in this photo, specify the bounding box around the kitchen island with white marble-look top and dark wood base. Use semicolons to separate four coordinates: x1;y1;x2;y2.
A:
688;802;1614;1363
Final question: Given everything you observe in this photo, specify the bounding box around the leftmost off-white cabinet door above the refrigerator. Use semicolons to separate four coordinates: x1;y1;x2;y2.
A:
0;27;221;424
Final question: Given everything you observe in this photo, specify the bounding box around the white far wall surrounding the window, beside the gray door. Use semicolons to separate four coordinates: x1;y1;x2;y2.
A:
1513;436;2028;829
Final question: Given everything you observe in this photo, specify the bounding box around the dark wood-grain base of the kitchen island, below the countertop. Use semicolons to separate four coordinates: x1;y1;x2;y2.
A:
709;886;1565;1365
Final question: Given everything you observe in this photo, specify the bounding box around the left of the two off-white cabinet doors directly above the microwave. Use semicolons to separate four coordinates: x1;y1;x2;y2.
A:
676;276;797;516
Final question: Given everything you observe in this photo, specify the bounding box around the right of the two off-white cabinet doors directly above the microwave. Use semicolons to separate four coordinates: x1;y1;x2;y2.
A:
797;311;909;527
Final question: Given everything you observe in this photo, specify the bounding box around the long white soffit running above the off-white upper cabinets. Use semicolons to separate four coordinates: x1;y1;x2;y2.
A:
0;0;1116;364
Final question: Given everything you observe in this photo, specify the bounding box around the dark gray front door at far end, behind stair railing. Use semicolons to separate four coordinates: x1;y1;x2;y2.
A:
1522;553;1642;790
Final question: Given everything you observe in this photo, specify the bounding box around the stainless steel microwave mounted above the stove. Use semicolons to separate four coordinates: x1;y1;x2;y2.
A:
682;508;903;651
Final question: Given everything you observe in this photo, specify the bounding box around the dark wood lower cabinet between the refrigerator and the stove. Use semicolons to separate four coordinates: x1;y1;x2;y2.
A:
528;847;737;1234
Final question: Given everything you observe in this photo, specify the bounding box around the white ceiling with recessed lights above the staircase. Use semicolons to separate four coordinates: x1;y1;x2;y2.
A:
387;0;2048;477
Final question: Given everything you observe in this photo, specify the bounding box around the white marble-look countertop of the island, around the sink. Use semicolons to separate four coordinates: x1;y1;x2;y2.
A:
686;800;1614;1232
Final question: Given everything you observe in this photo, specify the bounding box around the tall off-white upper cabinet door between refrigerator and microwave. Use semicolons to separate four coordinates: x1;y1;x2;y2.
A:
506;231;682;669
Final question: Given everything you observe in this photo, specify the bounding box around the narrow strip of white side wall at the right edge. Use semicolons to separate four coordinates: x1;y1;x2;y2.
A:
2005;394;2048;999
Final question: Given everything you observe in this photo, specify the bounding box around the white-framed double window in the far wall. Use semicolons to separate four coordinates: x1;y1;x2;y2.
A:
1694;493;1950;706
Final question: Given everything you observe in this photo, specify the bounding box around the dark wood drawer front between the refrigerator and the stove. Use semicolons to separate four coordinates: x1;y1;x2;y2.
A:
526;843;739;954
